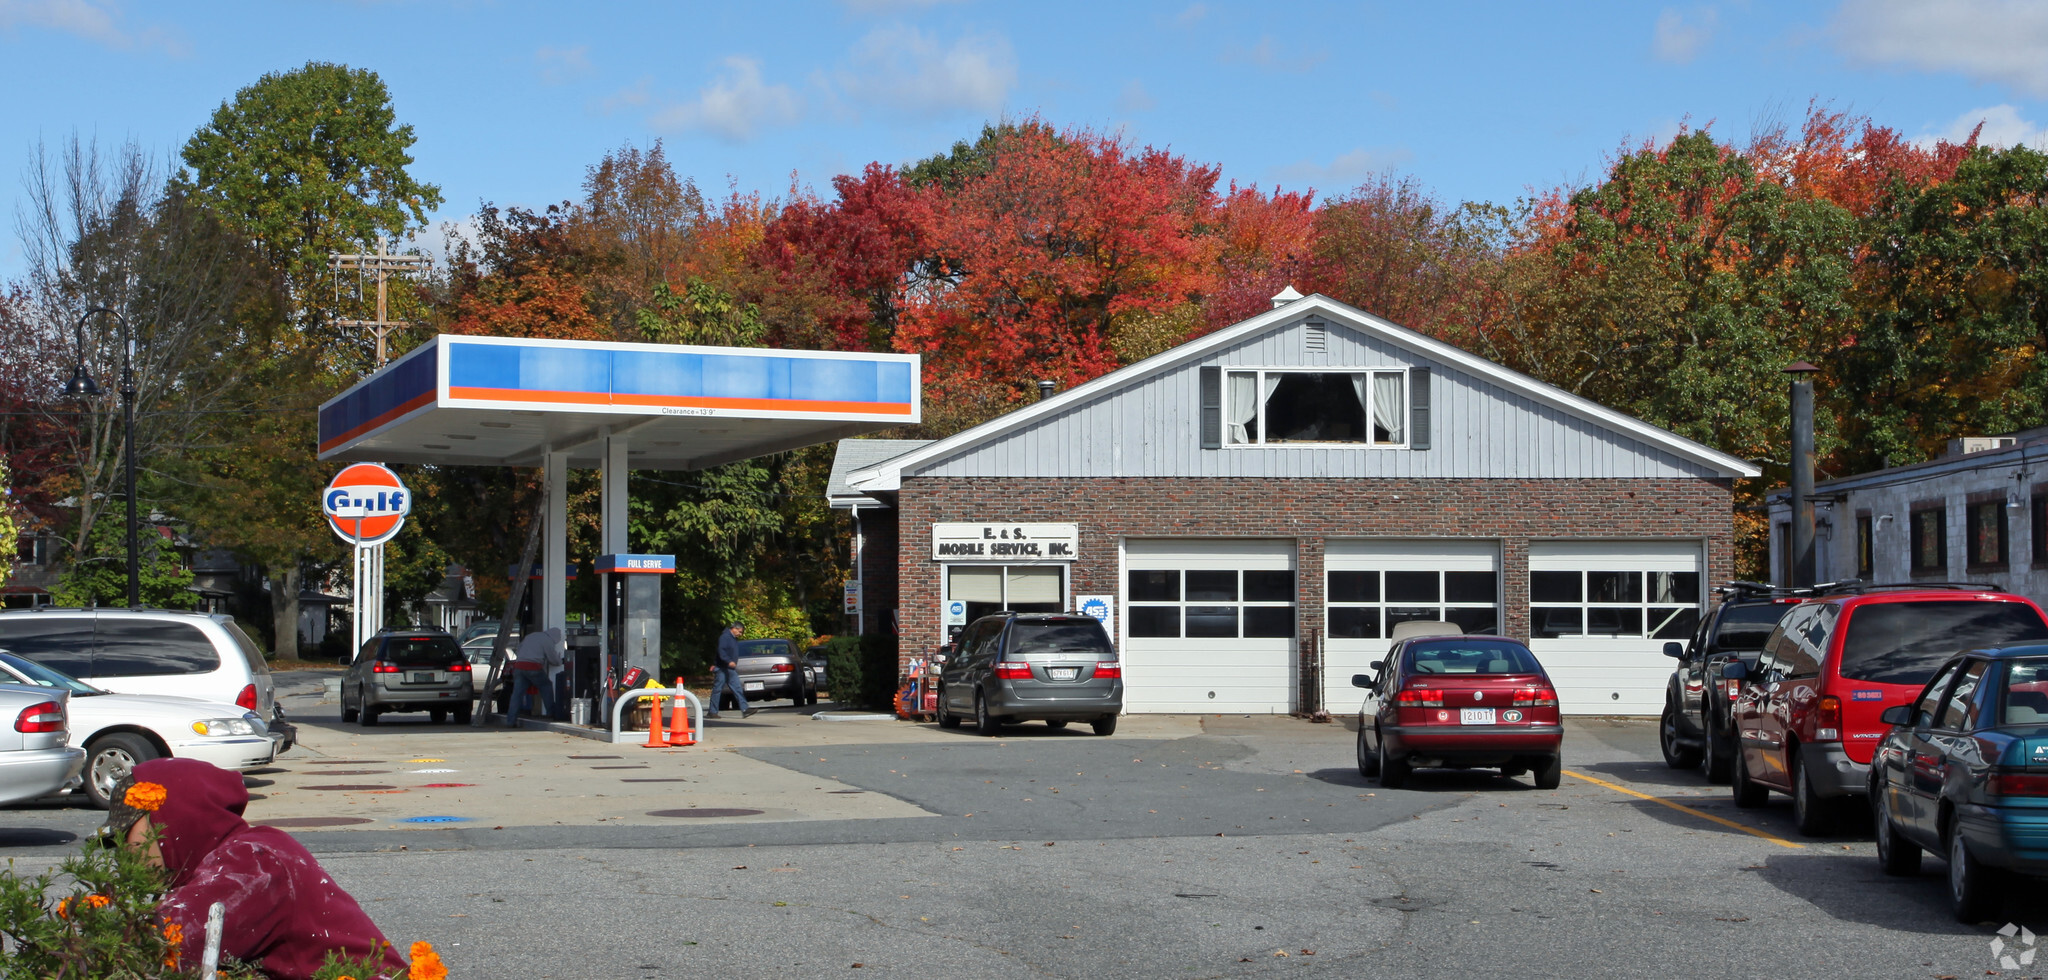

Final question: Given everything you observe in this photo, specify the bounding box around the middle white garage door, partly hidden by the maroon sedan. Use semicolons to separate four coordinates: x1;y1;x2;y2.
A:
1323;538;1501;714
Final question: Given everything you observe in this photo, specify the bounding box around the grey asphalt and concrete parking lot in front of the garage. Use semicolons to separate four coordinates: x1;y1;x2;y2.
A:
0;675;2048;978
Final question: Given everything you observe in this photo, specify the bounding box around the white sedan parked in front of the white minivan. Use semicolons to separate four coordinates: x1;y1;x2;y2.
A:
0;653;276;810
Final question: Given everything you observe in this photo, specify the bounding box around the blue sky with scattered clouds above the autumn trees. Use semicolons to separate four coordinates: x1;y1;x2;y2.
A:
0;0;2048;278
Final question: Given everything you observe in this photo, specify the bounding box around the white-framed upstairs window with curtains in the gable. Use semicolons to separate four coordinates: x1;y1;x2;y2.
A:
1221;370;1409;448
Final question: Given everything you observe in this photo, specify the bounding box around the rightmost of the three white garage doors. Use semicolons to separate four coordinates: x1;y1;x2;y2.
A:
1530;542;1704;714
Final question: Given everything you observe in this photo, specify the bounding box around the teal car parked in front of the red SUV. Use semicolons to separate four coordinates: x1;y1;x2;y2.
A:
1875;644;2048;923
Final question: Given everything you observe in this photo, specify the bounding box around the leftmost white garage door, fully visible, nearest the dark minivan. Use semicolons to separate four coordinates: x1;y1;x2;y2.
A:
1122;538;1298;714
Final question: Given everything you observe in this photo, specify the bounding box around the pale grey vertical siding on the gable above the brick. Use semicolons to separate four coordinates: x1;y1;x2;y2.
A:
905;321;1716;479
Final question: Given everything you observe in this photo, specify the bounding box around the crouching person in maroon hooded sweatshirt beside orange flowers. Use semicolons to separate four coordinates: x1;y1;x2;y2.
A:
104;759;406;980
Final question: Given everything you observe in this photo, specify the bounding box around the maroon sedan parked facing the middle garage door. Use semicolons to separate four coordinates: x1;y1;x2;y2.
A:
1352;636;1565;790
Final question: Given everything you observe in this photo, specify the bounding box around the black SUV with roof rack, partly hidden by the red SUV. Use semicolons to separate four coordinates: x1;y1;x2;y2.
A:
1657;581;1825;784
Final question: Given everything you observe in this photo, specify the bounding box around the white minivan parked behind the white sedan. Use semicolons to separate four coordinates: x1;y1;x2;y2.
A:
0;606;276;722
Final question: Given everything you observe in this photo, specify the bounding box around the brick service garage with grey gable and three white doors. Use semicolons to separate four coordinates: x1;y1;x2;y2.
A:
827;293;1757;714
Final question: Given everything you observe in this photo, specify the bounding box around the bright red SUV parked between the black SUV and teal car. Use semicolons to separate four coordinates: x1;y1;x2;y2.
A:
1722;585;2048;837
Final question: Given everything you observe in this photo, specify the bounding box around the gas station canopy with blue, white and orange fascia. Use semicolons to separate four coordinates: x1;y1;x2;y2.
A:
319;333;922;471
